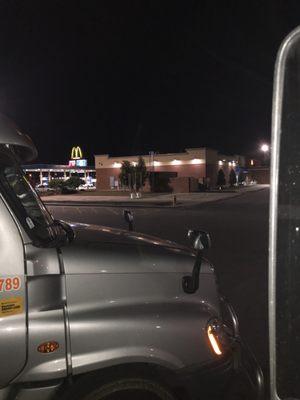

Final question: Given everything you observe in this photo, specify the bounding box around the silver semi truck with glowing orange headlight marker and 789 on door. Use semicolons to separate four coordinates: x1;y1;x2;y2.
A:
0;115;263;400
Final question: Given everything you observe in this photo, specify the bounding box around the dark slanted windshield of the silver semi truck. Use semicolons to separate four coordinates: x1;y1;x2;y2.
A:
0;145;55;245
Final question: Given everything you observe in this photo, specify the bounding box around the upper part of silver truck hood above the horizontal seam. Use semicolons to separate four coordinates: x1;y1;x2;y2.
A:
61;224;213;274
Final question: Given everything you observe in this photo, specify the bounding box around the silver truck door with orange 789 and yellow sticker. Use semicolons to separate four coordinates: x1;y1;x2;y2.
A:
0;197;27;387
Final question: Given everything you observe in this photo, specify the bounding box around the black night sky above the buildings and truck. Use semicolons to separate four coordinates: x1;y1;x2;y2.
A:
0;0;300;163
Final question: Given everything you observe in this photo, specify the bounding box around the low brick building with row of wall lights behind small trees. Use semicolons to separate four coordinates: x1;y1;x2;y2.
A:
95;147;245;192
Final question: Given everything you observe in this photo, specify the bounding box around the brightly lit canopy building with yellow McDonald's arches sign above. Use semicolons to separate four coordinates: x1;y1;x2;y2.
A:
23;146;96;186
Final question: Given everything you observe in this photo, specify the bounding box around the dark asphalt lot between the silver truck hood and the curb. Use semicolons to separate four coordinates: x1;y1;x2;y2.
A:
49;189;269;384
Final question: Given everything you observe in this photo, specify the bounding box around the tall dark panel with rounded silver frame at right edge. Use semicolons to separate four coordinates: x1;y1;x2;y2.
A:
269;28;300;400
